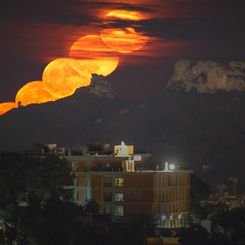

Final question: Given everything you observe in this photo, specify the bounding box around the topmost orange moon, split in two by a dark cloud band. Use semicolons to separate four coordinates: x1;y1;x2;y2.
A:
100;10;148;53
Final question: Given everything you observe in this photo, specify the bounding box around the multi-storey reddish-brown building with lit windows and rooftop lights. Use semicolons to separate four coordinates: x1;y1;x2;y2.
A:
28;142;192;228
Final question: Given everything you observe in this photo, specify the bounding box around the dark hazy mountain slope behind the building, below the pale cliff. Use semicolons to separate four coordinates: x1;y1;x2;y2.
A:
0;64;245;190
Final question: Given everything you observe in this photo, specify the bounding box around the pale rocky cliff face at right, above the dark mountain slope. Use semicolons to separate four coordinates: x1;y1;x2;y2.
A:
167;60;245;93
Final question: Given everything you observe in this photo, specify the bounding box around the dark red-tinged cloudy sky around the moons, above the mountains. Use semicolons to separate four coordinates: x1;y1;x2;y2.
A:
0;0;245;102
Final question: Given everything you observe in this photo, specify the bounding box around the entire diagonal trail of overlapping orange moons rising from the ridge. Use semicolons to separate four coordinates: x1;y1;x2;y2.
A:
0;10;149;115
